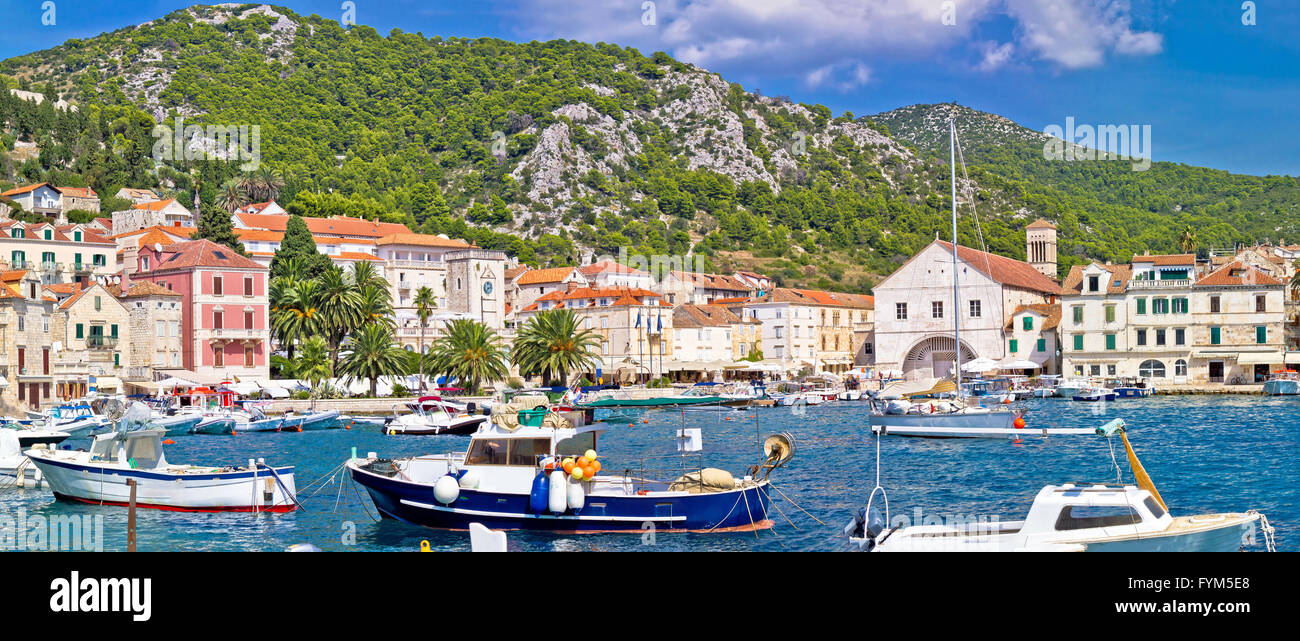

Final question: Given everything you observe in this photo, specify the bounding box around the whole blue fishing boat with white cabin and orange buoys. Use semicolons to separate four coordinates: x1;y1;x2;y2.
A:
346;410;794;533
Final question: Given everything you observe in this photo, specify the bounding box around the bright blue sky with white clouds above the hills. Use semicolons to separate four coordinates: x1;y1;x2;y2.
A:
0;0;1300;176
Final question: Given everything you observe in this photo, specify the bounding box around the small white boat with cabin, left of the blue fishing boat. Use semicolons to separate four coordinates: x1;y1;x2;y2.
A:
26;403;298;512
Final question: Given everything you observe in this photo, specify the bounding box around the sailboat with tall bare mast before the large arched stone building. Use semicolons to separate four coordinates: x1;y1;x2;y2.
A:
871;120;1071;438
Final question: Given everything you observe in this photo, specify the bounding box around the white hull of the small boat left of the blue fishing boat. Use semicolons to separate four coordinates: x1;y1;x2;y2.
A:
31;455;296;512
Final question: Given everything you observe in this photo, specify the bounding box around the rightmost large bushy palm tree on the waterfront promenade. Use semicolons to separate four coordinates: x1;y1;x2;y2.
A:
510;309;601;385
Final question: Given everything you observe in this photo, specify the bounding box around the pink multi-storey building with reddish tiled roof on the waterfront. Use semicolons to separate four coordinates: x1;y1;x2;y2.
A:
130;241;270;384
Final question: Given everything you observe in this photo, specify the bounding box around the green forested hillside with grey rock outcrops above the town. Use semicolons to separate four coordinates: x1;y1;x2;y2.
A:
0;5;1297;291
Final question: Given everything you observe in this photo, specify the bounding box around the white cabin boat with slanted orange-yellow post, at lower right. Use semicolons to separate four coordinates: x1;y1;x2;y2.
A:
845;419;1274;551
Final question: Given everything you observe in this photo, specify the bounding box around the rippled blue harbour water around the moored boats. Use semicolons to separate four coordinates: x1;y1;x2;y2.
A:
0;395;1300;551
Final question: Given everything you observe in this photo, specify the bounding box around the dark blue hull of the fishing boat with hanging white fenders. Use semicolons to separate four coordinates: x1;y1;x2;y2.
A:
348;465;772;533
